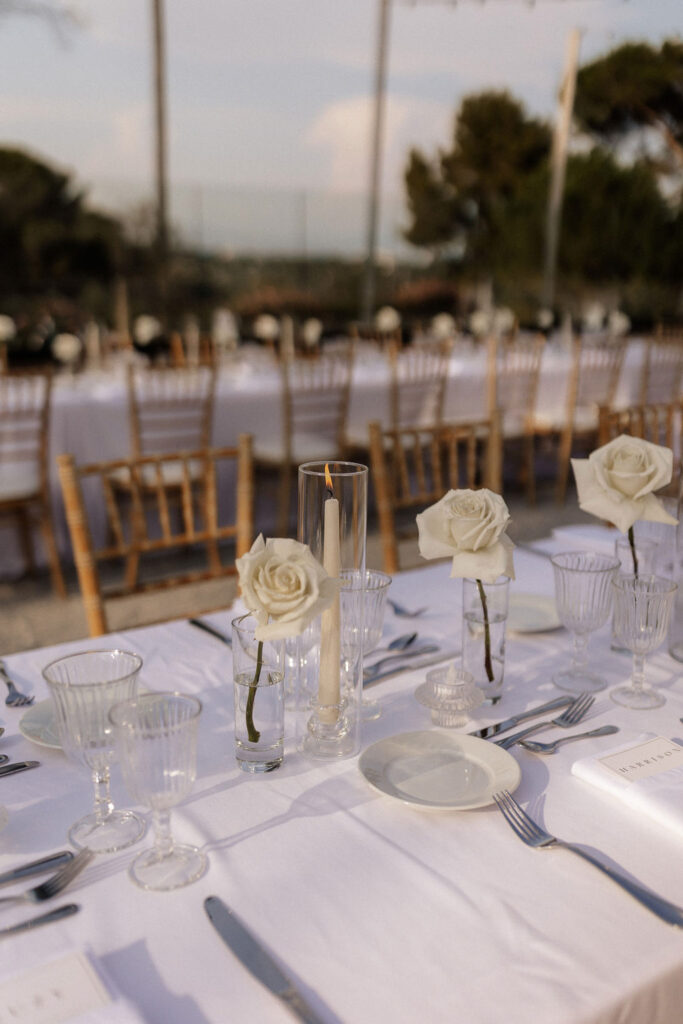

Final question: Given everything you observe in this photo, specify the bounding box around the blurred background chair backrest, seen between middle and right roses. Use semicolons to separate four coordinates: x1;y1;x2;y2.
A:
495;334;546;435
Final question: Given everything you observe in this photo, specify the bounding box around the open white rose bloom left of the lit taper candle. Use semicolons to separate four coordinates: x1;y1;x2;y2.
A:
236;534;339;640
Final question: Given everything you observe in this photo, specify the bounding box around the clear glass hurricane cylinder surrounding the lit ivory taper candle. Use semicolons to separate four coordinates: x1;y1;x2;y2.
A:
297;462;368;760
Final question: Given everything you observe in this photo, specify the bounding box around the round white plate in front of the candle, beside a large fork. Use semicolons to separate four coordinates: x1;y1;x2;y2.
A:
358;730;521;811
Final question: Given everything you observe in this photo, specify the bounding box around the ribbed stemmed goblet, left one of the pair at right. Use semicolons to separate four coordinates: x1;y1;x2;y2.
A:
551;551;620;693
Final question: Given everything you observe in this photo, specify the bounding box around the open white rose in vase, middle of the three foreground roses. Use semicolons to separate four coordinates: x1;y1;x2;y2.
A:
417;487;515;583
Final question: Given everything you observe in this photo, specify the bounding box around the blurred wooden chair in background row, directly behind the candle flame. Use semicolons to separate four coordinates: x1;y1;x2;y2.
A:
254;350;352;537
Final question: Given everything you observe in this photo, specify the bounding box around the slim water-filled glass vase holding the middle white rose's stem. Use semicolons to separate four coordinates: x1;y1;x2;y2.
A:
463;577;510;698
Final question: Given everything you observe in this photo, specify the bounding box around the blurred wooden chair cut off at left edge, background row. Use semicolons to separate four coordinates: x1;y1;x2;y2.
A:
0;374;67;597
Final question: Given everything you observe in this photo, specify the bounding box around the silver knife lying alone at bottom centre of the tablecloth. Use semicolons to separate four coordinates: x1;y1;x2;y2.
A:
204;896;323;1024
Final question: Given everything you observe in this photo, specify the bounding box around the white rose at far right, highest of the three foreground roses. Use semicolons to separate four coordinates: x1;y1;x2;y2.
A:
571;434;677;534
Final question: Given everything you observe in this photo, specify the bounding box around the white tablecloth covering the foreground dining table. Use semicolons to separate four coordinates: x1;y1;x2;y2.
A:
0;549;683;1024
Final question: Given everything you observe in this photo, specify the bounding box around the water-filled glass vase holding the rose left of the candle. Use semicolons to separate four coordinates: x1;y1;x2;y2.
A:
232;614;286;773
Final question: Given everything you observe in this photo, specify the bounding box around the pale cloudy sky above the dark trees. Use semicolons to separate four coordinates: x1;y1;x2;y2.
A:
0;0;683;253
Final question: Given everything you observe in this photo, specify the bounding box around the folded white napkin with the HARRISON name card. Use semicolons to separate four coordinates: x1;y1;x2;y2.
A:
571;733;683;839
